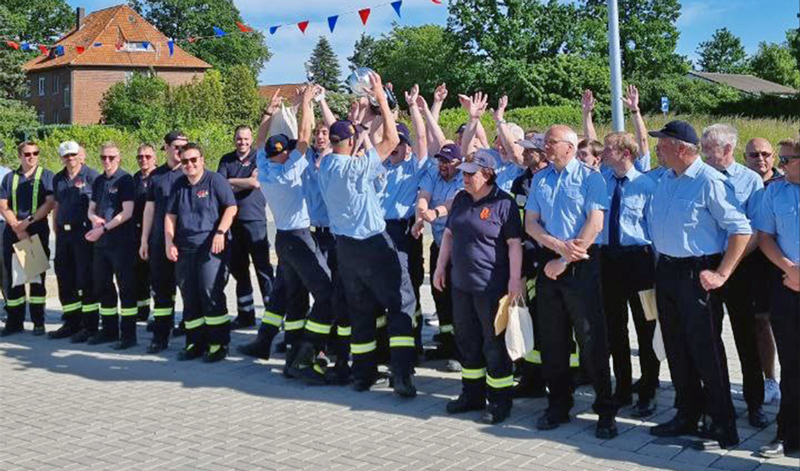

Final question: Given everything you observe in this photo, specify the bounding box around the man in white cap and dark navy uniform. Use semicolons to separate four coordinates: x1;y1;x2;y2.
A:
50;141;100;343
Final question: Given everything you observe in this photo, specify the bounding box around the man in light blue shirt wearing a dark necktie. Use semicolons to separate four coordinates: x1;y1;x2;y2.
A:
602;132;660;417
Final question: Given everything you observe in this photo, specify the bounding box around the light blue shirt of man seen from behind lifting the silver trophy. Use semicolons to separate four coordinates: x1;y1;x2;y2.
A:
319;148;386;240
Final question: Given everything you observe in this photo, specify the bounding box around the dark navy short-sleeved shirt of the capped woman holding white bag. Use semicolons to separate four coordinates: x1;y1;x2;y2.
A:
447;185;522;293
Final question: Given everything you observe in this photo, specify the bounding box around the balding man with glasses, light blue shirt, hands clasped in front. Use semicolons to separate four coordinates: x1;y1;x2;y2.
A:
525;126;617;439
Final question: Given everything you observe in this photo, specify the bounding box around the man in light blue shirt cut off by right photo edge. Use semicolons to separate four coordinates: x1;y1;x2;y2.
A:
754;139;800;458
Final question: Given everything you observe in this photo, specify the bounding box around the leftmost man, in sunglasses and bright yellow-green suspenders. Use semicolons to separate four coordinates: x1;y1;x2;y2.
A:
0;141;54;336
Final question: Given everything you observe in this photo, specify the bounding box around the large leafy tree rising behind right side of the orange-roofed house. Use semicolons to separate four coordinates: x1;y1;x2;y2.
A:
129;0;271;75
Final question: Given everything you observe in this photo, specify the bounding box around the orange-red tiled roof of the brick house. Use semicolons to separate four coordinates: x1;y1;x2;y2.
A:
23;5;211;72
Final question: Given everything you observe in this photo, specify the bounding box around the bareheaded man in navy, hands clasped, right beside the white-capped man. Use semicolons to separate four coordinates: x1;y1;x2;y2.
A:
85;143;138;350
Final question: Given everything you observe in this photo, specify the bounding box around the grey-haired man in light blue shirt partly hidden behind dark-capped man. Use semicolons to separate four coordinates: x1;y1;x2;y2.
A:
700;124;769;429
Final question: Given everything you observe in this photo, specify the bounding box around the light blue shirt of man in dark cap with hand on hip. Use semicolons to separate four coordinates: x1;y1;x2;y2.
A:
647;157;752;257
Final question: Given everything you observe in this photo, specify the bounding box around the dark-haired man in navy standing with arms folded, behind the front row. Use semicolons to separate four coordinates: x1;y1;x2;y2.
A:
217;126;274;329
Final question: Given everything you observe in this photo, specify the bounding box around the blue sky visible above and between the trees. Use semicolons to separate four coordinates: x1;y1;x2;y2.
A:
68;0;799;84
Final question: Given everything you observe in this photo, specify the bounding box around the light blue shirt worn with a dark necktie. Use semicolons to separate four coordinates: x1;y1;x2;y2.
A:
601;166;656;246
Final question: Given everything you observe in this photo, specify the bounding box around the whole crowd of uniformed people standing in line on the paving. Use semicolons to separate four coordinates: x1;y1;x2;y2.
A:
0;73;800;457
